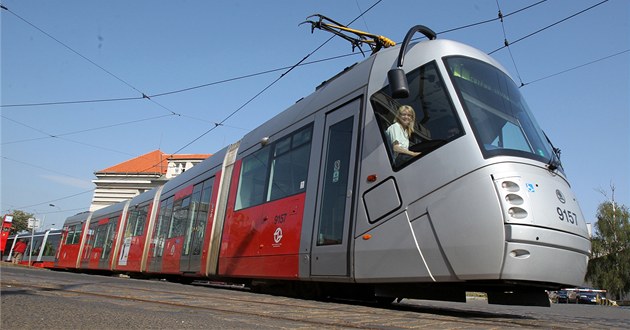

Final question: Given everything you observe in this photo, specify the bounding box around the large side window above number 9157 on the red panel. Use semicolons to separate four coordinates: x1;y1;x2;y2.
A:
234;125;313;210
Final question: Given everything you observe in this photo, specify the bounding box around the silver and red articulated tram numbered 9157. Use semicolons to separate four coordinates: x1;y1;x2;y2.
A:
56;26;590;306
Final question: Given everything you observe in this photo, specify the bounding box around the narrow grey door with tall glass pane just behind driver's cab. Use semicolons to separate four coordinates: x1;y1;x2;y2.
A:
311;100;361;276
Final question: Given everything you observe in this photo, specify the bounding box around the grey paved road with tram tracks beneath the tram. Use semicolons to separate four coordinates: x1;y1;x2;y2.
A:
0;263;630;329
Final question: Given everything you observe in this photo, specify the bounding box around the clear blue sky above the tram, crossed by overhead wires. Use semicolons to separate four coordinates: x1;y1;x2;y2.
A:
0;0;630;228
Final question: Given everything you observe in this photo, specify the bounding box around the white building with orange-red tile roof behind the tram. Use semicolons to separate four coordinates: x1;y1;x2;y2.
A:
90;150;211;211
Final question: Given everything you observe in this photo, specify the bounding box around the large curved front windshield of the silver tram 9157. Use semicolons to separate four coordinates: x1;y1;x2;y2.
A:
445;56;560;168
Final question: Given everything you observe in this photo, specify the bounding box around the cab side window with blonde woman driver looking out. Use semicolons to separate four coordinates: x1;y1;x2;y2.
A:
370;62;464;169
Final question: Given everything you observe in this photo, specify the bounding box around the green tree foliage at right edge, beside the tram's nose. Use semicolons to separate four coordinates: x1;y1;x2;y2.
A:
586;201;630;299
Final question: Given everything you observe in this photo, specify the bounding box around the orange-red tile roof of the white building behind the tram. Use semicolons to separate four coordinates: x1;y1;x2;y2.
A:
96;150;211;174
